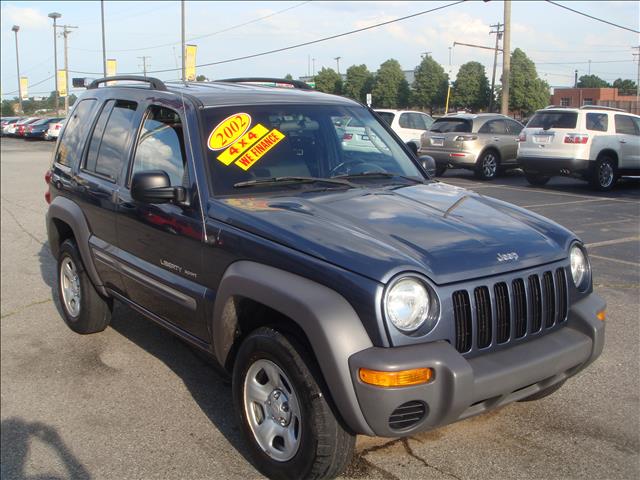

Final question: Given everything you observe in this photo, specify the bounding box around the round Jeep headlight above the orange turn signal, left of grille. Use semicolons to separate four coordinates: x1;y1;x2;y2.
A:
384;277;437;332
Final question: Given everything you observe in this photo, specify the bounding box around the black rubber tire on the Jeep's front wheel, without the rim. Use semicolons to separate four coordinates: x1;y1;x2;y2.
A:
232;327;355;479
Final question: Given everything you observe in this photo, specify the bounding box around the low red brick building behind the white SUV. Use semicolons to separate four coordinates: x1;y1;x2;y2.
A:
551;88;640;114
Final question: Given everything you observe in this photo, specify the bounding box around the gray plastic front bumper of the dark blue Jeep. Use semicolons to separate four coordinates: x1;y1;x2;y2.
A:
349;294;605;437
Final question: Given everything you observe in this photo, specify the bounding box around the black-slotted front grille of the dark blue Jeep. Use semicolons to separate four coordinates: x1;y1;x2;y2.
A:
452;268;569;353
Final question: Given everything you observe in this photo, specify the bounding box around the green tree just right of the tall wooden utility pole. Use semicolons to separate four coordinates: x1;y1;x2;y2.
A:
498;48;550;117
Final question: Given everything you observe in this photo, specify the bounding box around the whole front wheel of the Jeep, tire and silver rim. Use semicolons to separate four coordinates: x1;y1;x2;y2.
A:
232;328;355;479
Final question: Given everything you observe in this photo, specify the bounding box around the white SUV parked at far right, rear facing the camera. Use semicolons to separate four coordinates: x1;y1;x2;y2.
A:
518;105;640;190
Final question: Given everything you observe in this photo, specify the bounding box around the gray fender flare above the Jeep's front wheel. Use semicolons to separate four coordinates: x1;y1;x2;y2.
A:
212;261;374;435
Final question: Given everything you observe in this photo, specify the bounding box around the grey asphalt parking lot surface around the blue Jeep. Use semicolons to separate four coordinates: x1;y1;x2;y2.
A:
0;138;640;480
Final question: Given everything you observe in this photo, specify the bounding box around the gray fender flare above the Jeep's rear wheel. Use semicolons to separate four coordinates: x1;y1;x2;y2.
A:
47;196;107;296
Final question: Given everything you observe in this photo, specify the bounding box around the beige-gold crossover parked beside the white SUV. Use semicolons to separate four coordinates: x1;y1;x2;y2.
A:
418;113;524;180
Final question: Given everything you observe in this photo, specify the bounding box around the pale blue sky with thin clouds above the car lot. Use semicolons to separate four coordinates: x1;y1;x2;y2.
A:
0;0;640;98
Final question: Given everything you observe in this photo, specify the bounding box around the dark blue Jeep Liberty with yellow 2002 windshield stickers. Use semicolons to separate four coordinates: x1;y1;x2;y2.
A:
45;76;605;479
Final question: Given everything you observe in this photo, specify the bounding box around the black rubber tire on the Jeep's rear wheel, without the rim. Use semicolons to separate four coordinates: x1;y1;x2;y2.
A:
57;240;113;334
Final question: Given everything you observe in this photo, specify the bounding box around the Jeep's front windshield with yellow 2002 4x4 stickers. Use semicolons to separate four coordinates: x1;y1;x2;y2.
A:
203;105;425;196
